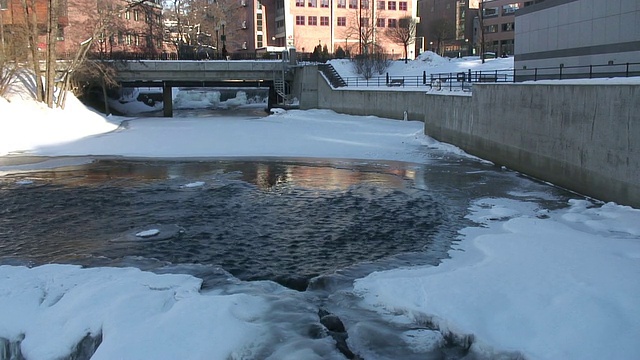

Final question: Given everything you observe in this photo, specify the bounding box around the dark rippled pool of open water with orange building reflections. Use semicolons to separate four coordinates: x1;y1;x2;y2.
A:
0;159;568;290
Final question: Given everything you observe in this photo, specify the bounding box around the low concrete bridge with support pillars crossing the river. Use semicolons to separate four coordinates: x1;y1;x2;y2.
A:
113;56;295;117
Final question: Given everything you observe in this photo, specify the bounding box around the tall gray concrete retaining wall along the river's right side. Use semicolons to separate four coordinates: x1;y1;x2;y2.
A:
297;67;640;208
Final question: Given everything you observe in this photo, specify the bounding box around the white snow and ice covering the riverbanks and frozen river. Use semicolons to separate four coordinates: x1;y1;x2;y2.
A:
0;54;640;360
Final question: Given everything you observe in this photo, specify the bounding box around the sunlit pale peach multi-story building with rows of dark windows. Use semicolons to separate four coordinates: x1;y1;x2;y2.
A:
256;0;420;58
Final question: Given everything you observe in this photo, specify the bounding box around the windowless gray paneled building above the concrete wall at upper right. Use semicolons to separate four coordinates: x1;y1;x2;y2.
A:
514;0;640;73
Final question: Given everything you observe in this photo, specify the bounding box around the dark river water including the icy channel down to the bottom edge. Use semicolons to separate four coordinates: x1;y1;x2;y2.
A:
0;102;571;359
